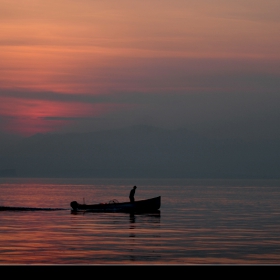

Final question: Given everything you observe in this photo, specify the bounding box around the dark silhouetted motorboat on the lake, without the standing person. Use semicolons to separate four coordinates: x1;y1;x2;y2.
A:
70;196;161;213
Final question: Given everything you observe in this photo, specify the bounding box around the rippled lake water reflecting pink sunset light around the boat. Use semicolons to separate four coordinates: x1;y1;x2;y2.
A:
0;178;280;265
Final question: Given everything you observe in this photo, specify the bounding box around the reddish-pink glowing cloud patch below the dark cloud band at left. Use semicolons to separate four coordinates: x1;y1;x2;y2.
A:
0;97;126;136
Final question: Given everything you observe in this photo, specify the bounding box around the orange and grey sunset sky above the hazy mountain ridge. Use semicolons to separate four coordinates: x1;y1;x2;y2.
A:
0;0;280;139
